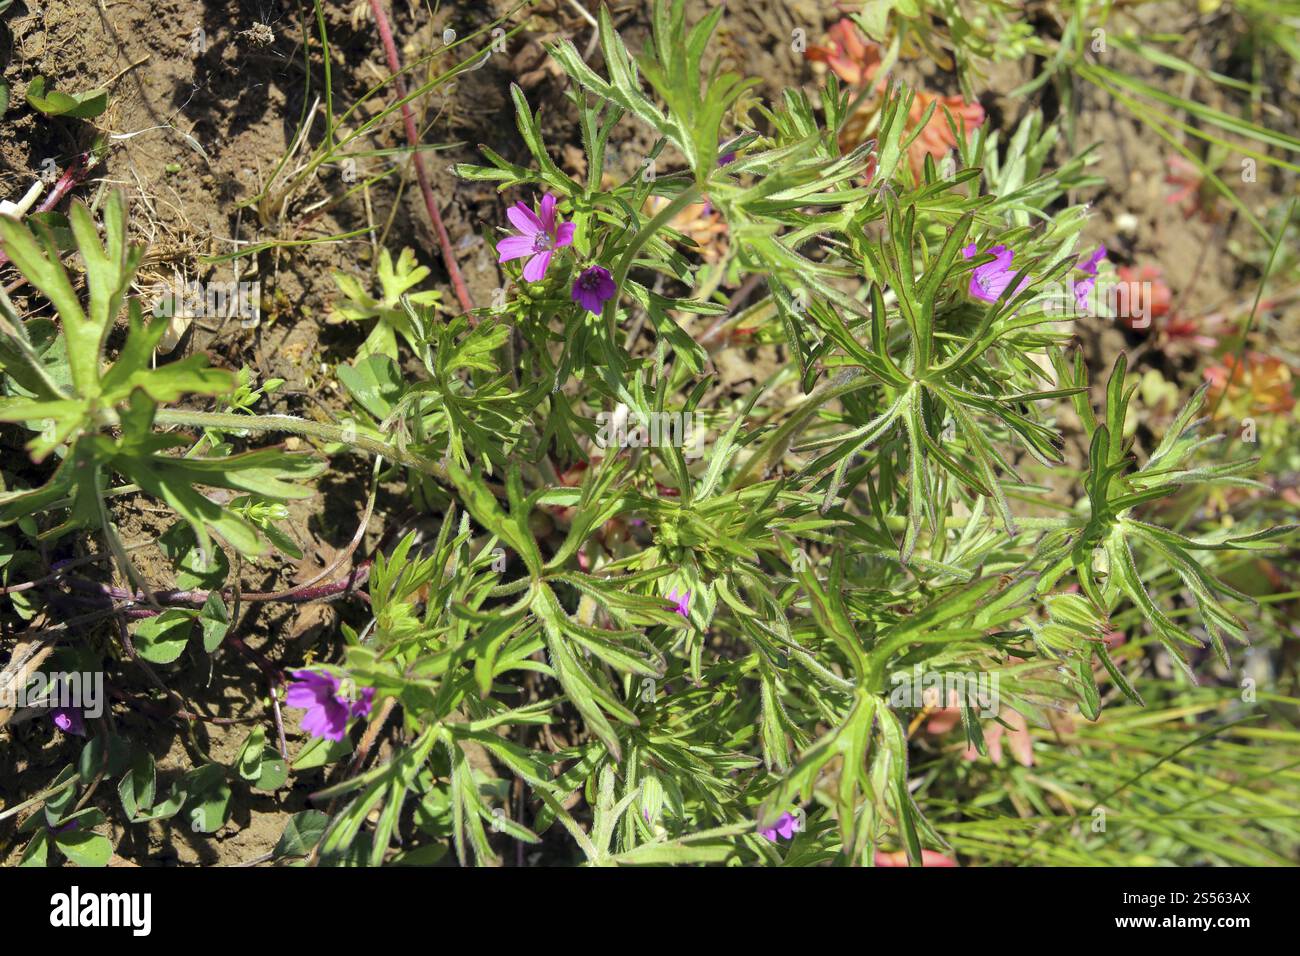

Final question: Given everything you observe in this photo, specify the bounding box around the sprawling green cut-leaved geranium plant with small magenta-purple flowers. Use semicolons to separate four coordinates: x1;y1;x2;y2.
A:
0;0;1295;866
